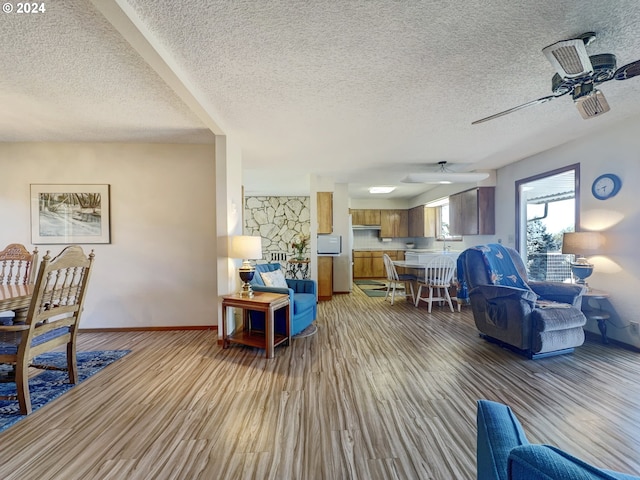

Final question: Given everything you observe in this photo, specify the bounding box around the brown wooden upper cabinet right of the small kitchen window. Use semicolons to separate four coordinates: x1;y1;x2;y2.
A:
449;187;496;235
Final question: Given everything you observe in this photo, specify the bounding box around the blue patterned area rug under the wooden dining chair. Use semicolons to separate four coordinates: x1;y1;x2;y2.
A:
0;350;130;432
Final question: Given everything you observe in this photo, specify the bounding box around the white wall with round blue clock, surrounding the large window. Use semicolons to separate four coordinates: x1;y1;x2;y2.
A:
496;119;640;347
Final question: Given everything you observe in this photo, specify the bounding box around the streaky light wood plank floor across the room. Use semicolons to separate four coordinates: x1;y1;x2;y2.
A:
0;288;640;480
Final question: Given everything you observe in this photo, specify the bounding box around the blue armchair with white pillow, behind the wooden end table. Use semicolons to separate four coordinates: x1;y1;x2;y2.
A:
251;263;318;335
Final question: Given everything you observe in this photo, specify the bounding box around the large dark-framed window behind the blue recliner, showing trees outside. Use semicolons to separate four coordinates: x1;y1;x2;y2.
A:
516;164;580;282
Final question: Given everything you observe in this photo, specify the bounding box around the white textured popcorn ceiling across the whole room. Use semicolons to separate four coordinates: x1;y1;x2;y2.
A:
0;0;640;196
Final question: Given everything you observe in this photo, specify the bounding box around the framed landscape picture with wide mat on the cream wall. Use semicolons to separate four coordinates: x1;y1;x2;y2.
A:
31;184;111;245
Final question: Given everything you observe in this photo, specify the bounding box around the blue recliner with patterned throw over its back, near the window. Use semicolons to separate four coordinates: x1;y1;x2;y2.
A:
458;244;586;358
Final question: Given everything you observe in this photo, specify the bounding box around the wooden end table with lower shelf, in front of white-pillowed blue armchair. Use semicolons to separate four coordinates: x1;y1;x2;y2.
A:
222;292;291;358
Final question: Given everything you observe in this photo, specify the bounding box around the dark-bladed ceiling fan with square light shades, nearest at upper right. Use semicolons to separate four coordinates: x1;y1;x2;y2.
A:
471;32;640;125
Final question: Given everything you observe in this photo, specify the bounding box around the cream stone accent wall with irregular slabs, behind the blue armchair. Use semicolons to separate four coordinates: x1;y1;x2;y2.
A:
244;196;311;271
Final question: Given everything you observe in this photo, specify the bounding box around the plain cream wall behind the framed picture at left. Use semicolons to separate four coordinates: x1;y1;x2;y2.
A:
0;143;218;328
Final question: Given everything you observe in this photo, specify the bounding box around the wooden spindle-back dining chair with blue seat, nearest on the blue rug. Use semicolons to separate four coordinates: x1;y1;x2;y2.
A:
0;245;94;415
